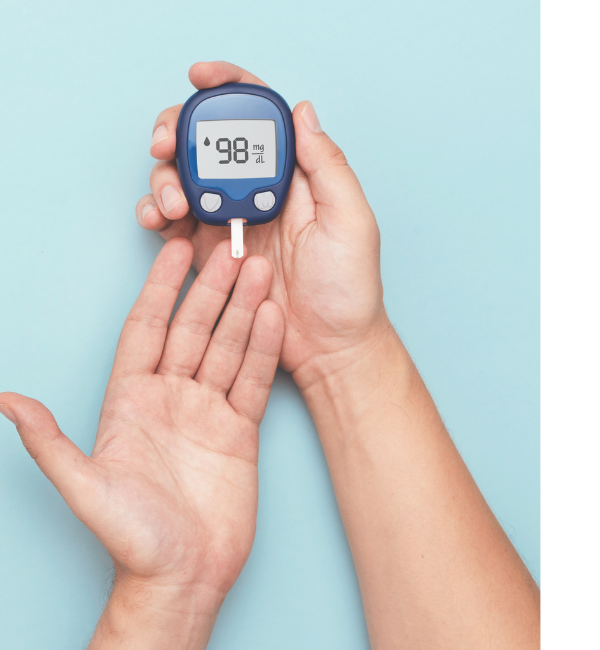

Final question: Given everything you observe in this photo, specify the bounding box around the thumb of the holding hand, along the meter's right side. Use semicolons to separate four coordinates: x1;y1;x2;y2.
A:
294;102;375;234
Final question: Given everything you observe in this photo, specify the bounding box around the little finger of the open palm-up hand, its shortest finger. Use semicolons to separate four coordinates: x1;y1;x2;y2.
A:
227;300;284;425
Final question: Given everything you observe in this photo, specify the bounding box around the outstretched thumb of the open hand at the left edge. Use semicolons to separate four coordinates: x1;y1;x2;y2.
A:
0;393;94;516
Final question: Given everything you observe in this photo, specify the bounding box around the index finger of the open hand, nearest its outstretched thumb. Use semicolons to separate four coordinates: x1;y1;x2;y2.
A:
113;238;194;377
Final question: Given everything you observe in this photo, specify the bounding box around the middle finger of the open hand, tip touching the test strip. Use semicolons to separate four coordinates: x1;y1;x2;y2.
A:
157;240;243;377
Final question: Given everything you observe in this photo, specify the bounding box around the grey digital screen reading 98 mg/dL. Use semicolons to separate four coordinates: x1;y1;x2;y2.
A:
196;120;277;180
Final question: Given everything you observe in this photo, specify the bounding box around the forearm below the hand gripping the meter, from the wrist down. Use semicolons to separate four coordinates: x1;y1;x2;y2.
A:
296;328;540;650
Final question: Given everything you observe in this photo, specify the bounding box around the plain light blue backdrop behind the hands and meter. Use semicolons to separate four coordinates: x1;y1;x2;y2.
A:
0;0;541;650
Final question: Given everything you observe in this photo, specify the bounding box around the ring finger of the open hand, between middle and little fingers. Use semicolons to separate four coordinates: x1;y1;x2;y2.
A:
196;255;273;393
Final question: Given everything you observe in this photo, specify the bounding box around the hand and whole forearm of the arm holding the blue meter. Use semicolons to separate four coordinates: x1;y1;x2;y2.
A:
137;62;541;650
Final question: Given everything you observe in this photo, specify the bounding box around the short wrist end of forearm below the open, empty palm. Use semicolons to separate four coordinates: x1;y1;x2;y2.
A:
89;580;223;650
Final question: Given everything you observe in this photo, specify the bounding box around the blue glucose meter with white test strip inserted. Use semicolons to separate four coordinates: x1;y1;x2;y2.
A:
177;83;296;257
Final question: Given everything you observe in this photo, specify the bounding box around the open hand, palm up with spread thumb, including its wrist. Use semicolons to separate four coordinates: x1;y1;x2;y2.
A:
0;239;283;650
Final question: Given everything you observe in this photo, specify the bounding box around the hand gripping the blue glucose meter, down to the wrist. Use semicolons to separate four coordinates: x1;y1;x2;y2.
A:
136;63;387;373
